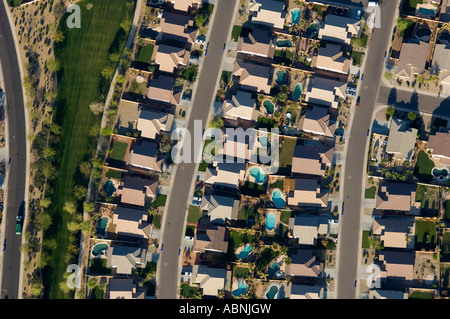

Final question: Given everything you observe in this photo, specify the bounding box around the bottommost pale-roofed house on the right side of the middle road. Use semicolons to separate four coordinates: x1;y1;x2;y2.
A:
192;265;227;297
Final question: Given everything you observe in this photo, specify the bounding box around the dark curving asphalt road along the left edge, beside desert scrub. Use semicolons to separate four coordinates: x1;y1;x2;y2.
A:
0;1;27;299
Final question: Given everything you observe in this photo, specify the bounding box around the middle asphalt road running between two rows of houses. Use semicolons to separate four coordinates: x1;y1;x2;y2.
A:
157;0;236;299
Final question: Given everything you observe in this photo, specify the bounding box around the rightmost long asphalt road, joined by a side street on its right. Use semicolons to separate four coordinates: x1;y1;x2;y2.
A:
336;0;397;299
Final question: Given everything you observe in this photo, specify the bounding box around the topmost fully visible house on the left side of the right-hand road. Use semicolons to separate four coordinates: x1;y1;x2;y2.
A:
318;14;361;44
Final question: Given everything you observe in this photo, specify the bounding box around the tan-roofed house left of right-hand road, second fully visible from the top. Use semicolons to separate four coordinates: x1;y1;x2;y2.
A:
311;43;350;74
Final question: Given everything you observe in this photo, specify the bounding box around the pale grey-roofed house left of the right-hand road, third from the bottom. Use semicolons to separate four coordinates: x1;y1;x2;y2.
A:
289;214;328;245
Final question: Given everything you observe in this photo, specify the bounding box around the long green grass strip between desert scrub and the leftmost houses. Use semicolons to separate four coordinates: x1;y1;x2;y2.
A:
43;0;134;299
